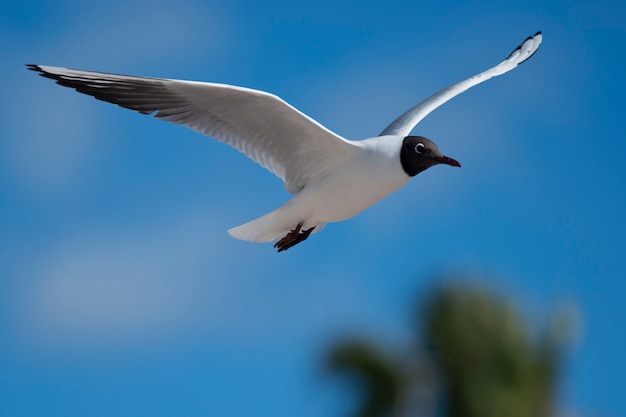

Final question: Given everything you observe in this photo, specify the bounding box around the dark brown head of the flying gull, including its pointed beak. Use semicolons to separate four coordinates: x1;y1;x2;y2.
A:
400;136;461;177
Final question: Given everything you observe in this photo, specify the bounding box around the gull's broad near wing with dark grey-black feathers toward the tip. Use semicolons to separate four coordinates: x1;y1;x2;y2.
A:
28;65;355;192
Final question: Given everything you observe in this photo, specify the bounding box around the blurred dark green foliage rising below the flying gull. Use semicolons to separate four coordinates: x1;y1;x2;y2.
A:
328;284;565;417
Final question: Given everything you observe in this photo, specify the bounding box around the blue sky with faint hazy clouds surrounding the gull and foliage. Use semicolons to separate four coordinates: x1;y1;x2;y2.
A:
0;0;626;416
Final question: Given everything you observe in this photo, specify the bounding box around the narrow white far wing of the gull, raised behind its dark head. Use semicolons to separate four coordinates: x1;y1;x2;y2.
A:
380;32;542;136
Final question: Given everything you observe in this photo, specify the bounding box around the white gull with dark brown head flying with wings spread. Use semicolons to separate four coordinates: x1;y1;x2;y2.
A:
27;32;542;252
